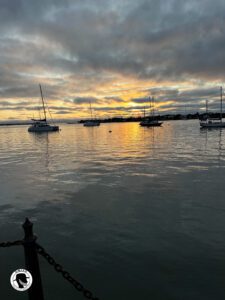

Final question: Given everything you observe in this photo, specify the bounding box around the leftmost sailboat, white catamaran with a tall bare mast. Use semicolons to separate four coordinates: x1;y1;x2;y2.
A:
28;84;59;132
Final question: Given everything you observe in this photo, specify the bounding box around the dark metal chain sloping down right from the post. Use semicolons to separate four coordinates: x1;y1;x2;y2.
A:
36;243;99;300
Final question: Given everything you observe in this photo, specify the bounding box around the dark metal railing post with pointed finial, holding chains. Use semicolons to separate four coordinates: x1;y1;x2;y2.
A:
23;218;44;300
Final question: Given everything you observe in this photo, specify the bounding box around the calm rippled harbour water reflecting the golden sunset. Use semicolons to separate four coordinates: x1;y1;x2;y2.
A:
0;121;225;300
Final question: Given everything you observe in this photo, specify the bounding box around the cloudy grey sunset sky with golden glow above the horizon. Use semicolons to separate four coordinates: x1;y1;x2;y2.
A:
0;0;225;120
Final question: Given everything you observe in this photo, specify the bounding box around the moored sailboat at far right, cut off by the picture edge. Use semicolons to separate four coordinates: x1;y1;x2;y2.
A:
200;86;225;128
